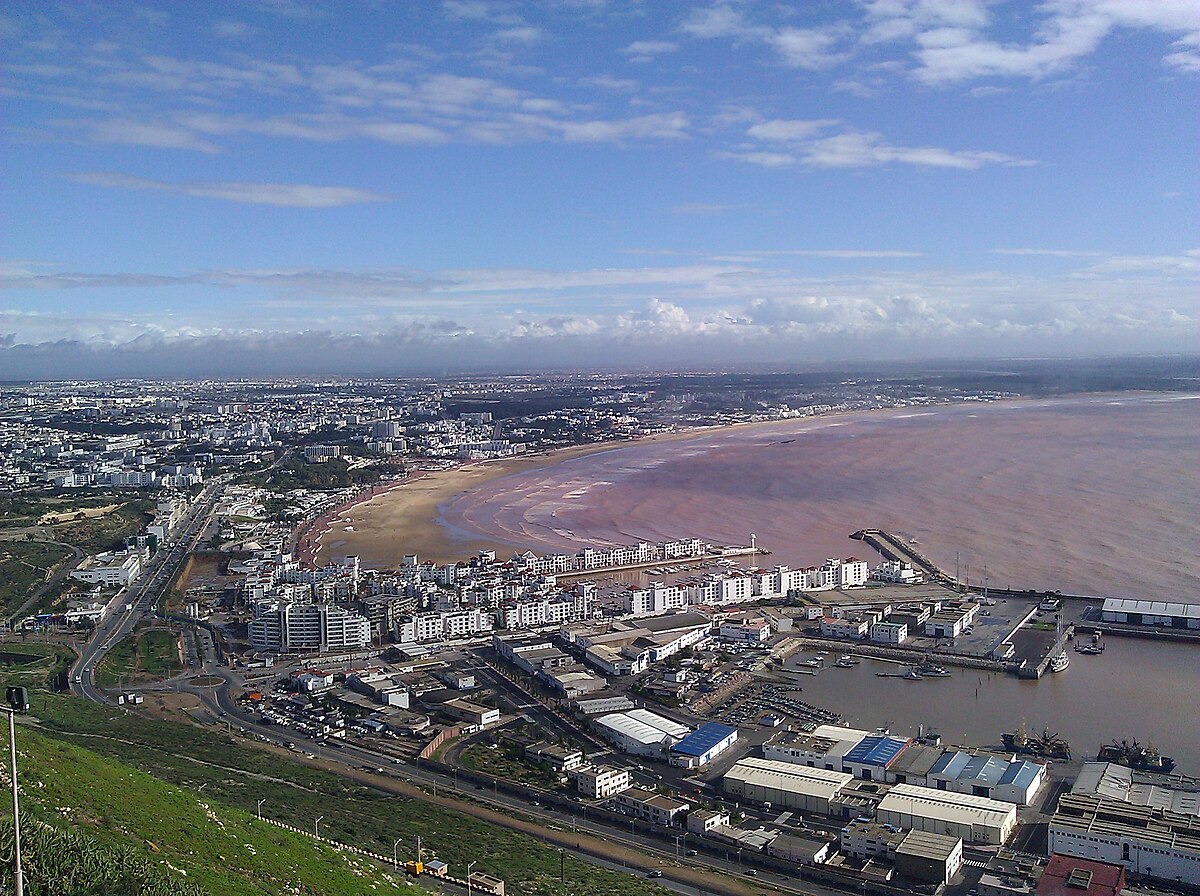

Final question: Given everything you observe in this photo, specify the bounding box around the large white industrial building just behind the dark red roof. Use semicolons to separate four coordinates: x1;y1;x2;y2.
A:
1048;793;1200;886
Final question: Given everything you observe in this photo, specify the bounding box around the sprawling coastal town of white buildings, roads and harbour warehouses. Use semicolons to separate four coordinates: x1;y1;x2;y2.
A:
0;371;1200;896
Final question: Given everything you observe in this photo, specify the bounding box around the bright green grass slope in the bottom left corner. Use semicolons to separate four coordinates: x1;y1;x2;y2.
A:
7;728;417;896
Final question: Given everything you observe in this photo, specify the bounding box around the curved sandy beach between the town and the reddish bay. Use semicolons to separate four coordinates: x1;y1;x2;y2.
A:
313;391;1123;569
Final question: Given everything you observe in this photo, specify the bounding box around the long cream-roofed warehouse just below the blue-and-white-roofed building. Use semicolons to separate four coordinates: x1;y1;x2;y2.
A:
875;784;1016;846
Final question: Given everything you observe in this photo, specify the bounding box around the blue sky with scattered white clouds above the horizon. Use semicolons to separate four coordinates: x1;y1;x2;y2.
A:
0;0;1200;378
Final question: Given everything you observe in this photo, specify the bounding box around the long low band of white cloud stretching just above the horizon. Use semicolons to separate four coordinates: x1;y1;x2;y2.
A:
0;249;1200;375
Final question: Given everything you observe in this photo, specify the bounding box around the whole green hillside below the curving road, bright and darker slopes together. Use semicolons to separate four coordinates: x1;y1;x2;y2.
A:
0;645;664;896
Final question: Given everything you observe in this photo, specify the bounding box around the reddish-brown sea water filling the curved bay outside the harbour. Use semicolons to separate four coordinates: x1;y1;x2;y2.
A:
442;395;1200;602
